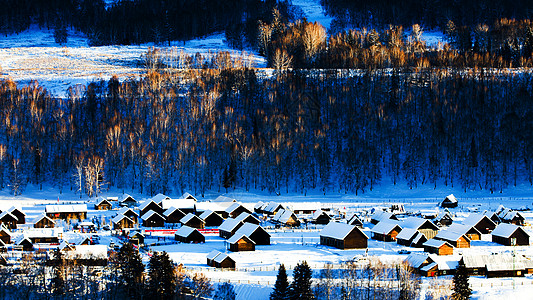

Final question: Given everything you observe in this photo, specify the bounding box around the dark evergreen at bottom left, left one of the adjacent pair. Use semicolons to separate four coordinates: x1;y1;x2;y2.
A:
117;243;144;298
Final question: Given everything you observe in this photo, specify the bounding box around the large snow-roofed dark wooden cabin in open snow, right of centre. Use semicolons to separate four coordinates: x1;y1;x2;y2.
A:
320;222;368;250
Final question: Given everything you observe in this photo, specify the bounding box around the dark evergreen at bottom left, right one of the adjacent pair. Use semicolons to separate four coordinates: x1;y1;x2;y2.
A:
147;252;176;300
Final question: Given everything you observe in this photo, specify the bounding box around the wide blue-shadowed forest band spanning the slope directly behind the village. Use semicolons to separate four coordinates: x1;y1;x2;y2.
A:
0;59;533;197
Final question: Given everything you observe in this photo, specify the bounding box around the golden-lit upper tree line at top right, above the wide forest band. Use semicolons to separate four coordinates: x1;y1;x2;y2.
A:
258;14;533;69
